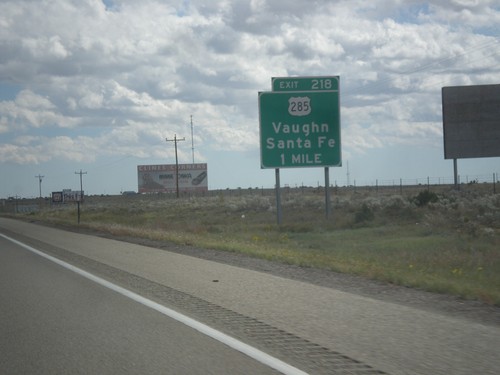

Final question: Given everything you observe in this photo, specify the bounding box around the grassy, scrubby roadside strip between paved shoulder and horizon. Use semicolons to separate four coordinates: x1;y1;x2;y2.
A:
1;187;500;306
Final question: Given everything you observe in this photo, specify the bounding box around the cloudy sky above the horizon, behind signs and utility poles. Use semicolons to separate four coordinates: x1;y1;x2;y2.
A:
0;0;500;198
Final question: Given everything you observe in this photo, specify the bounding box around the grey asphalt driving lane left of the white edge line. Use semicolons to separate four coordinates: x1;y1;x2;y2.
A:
0;237;286;375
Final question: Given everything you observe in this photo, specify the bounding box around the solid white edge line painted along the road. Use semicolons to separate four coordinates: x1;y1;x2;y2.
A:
0;233;307;375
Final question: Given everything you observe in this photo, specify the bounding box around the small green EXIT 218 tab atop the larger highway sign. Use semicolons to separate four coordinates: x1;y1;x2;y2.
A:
271;76;339;91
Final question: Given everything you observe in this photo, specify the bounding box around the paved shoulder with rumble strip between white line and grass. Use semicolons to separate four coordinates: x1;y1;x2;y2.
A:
0;218;500;375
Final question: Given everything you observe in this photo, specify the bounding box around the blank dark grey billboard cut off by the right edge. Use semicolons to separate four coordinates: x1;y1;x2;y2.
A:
442;84;500;159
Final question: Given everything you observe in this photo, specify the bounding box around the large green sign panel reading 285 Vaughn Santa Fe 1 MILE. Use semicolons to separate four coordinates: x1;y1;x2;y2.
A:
259;90;342;168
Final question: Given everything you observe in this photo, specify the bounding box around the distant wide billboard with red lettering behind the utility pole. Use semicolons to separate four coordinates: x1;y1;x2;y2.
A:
137;163;208;193
